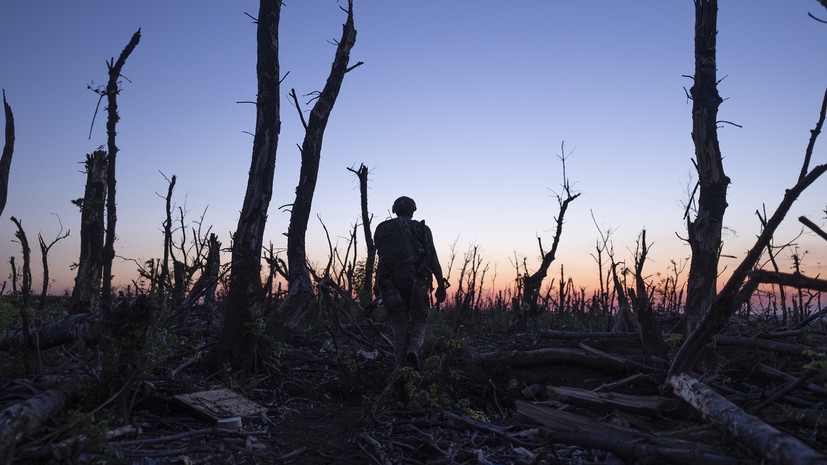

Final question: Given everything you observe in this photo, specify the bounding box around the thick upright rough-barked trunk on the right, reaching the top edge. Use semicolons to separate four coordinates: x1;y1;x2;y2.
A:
684;0;729;335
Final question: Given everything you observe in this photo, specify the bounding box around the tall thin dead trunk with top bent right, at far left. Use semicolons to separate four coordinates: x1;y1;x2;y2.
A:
101;29;141;314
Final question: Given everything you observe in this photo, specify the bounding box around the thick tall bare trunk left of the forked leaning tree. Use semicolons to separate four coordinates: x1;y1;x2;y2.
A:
216;0;282;367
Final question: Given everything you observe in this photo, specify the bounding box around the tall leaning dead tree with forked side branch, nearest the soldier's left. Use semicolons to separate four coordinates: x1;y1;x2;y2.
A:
270;0;361;330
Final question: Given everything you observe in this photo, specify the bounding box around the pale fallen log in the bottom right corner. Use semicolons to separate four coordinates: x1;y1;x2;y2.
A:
669;373;827;465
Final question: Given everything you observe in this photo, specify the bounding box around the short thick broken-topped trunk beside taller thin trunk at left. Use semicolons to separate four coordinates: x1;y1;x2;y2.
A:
69;150;107;313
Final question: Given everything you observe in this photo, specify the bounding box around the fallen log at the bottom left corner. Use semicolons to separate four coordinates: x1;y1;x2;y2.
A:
0;382;77;463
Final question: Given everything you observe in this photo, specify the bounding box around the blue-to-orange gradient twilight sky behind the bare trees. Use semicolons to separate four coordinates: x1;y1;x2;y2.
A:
0;0;827;293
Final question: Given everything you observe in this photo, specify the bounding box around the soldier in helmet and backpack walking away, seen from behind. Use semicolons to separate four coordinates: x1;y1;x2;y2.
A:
374;196;445;371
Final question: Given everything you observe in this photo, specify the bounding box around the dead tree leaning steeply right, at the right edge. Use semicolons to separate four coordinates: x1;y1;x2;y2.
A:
670;91;827;374
